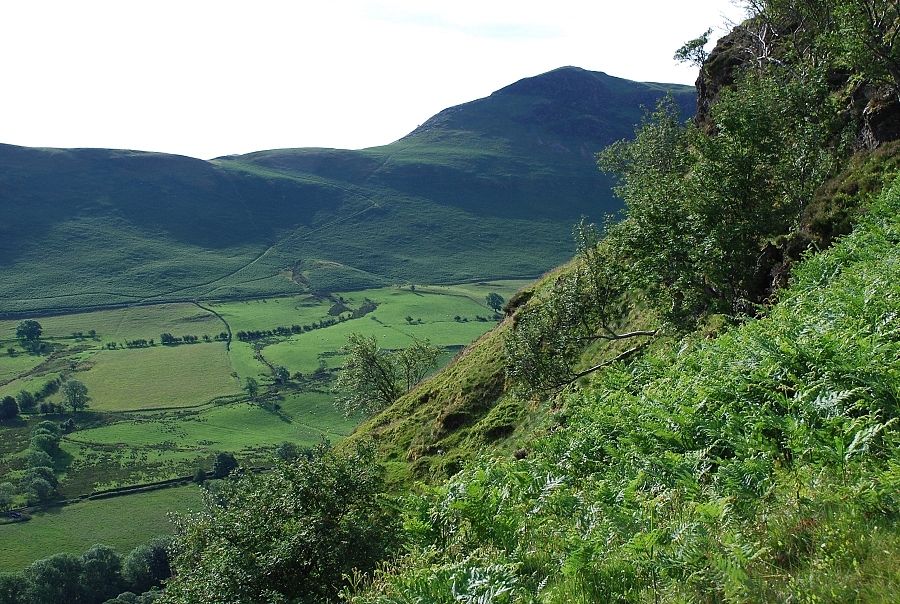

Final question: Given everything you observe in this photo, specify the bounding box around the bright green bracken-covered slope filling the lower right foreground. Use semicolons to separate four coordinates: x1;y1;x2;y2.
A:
346;172;900;603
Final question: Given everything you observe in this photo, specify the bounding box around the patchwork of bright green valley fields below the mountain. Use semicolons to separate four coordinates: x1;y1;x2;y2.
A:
0;281;526;570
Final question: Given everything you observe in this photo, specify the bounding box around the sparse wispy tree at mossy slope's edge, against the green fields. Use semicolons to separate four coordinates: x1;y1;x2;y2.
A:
334;333;439;415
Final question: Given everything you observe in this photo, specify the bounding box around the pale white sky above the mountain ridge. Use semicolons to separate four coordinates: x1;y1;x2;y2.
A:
0;0;743;159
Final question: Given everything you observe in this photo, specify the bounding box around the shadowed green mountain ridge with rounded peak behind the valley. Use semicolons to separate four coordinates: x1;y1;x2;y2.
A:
0;67;695;313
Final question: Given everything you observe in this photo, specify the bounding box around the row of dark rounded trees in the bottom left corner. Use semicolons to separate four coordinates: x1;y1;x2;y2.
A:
0;539;171;604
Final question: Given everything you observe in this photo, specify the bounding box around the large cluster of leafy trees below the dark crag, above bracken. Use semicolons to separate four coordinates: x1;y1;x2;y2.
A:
507;44;850;392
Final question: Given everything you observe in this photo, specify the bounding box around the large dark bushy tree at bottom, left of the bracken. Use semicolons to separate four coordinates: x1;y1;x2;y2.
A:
166;445;398;604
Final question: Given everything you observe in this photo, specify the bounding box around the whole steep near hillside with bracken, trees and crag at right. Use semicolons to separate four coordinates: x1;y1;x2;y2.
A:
155;1;900;604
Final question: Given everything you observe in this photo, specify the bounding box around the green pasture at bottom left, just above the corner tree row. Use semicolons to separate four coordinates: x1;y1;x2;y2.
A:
0;485;202;571
